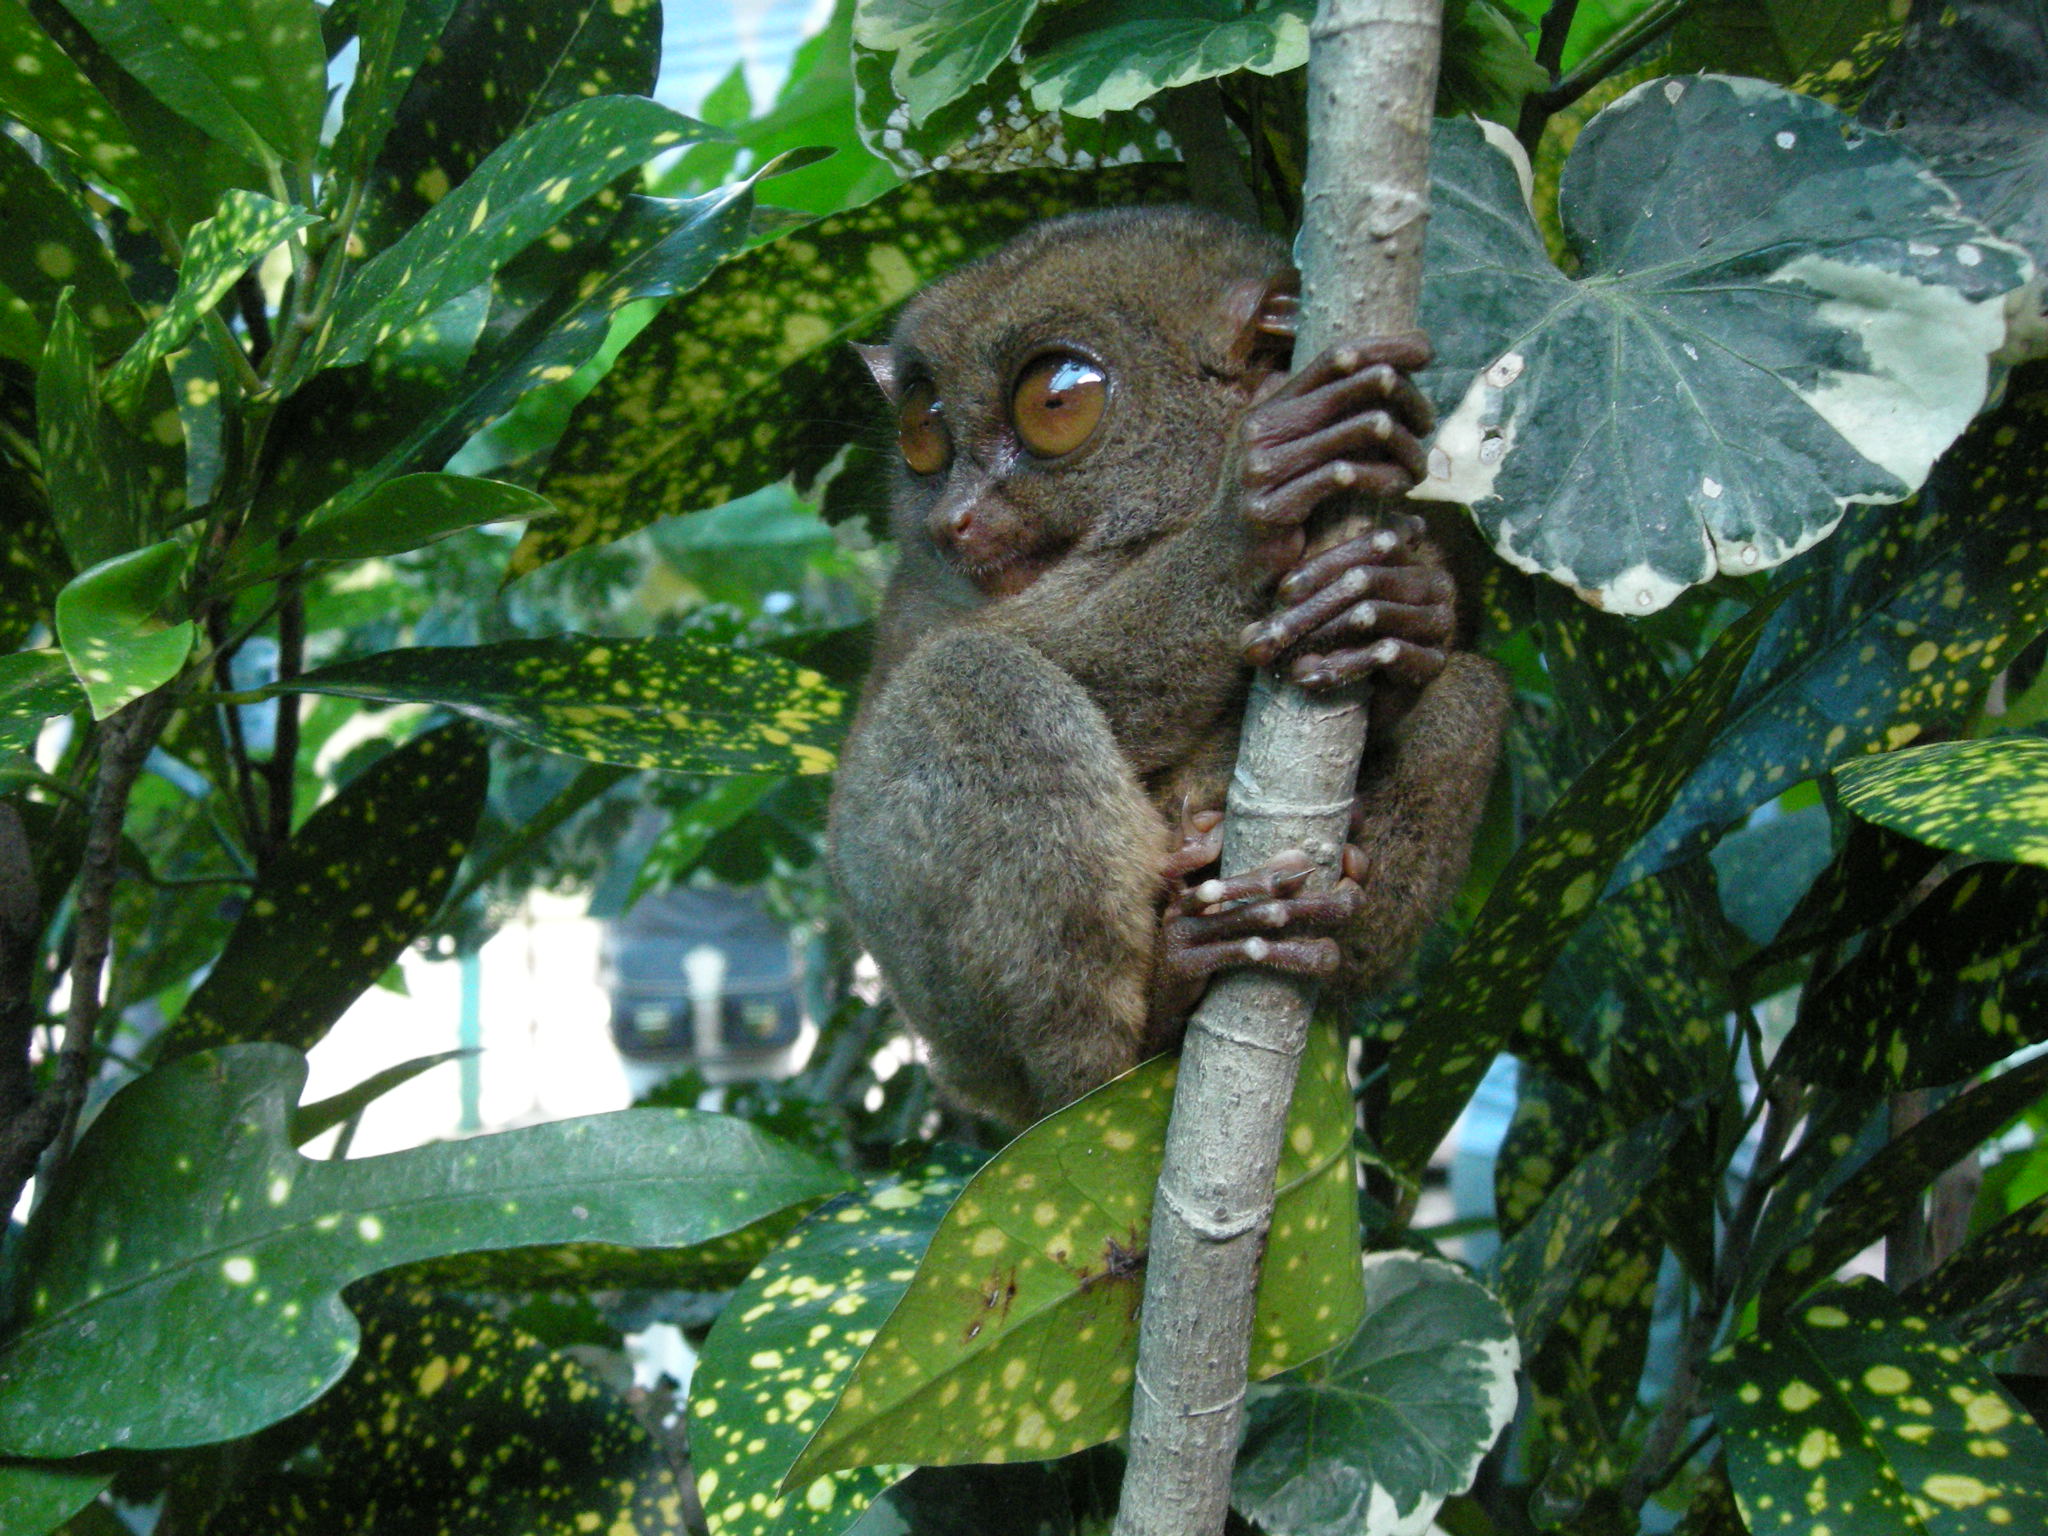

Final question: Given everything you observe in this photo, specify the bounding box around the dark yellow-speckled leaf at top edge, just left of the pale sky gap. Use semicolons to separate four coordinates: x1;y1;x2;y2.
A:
356;0;662;250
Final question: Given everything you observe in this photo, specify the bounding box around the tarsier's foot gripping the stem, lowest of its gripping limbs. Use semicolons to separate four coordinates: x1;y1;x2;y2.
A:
1151;811;1364;1047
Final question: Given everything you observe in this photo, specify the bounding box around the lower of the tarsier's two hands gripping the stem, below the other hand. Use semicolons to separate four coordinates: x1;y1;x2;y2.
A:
1243;514;1458;692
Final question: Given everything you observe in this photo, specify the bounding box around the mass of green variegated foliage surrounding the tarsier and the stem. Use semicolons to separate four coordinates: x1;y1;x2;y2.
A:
12;0;2048;1536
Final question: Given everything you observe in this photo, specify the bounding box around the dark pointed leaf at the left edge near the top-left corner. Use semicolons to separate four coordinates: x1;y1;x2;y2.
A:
0;132;141;360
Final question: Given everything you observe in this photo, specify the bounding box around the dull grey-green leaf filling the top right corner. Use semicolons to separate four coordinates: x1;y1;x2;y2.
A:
1862;0;2048;282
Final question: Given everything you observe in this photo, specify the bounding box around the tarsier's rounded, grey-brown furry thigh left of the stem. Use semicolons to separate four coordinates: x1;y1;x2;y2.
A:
834;629;1171;1124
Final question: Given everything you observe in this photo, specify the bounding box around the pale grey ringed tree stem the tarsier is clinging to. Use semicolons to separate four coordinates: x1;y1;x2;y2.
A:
1116;0;1442;1536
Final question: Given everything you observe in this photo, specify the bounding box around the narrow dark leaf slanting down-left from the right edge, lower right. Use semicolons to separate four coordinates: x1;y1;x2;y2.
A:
1763;1057;2048;1313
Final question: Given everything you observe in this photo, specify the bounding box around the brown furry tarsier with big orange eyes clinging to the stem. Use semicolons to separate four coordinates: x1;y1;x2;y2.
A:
831;209;1507;1124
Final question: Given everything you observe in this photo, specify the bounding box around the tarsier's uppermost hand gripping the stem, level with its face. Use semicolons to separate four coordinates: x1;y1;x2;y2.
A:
1241;332;1436;553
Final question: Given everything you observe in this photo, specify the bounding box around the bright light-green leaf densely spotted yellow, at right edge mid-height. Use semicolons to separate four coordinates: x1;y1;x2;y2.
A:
1835;735;2048;864
